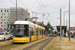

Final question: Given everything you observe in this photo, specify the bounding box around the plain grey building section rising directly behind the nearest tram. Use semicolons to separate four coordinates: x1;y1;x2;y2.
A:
9;8;32;24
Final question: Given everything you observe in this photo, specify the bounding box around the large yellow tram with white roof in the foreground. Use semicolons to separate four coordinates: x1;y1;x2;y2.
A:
13;21;45;43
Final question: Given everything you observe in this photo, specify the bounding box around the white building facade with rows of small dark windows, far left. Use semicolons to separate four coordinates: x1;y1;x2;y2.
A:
0;9;10;30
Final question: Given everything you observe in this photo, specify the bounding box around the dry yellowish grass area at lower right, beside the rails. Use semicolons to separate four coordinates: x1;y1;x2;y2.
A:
43;37;75;50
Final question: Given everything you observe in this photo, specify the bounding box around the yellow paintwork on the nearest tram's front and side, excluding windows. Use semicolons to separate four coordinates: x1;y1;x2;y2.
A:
13;24;45;43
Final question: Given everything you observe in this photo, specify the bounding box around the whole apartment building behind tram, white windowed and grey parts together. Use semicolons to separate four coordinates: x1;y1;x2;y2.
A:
0;7;33;30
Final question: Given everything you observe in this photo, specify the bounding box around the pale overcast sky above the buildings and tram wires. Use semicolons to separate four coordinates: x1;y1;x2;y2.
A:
0;0;75;27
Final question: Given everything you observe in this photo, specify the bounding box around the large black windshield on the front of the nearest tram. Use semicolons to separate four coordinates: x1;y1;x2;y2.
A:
13;25;29;37
